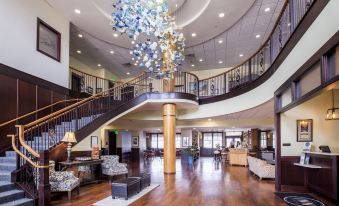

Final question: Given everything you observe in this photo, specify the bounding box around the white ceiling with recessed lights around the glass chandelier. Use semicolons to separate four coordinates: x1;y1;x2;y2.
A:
45;0;284;78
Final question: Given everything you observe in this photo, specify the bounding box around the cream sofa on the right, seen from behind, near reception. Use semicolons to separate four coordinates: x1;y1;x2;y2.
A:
247;156;275;180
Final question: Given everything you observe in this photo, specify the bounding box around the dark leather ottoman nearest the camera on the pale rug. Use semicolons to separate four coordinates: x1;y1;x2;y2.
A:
112;177;140;200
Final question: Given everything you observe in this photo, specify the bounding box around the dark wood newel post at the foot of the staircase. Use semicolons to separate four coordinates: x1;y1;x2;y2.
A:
38;150;51;206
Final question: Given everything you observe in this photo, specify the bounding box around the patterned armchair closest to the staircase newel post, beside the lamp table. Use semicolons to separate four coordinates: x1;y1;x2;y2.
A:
49;161;80;200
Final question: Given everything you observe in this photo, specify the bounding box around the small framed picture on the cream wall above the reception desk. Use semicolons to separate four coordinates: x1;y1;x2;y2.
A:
297;119;313;142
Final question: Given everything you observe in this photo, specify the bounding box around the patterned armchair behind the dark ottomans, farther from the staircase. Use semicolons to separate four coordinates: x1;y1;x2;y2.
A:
101;155;128;180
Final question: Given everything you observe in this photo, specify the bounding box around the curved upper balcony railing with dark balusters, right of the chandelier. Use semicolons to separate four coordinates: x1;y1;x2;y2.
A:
199;0;314;98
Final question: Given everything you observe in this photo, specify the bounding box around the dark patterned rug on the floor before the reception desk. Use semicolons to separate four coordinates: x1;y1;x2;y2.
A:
275;192;326;206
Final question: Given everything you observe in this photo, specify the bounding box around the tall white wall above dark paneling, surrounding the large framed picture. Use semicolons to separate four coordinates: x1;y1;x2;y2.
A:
0;0;69;87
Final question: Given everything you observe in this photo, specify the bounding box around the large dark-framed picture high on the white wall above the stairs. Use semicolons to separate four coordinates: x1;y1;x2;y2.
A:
36;18;61;62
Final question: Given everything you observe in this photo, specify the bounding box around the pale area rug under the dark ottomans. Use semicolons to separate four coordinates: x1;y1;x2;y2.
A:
93;184;159;206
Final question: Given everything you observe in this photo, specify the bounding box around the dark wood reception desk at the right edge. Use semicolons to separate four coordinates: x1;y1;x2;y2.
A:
294;152;339;200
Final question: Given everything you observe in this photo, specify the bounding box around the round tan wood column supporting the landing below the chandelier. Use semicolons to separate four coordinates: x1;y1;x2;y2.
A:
163;103;176;174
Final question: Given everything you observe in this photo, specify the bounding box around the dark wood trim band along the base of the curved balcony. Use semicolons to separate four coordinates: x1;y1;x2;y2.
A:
199;0;329;104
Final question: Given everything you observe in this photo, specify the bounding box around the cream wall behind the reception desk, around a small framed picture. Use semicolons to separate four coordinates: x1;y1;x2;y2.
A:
281;90;339;156
